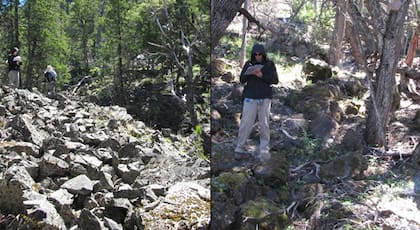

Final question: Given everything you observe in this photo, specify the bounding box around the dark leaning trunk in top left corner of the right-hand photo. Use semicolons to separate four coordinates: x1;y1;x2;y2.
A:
211;0;245;50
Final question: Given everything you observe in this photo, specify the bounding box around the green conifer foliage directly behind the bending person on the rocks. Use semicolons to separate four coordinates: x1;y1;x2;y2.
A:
21;0;69;88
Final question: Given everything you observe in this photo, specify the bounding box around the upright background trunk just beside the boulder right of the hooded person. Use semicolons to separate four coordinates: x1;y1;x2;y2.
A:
328;0;347;66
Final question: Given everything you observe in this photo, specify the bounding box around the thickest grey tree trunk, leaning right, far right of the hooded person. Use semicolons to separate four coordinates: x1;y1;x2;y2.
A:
366;0;410;147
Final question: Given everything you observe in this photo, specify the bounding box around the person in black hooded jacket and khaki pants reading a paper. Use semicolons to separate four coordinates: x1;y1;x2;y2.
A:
235;44;279;160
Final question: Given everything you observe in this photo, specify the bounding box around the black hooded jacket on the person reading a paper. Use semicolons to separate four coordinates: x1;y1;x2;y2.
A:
240;44;279;99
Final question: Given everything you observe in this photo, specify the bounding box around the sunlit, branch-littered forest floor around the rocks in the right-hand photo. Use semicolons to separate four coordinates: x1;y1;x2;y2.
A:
212;56;420;229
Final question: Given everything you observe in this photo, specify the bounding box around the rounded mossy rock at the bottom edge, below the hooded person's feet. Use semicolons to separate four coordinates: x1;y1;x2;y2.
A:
237;198;289;230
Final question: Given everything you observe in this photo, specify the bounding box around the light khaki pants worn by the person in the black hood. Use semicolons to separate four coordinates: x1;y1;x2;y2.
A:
236;98;271;153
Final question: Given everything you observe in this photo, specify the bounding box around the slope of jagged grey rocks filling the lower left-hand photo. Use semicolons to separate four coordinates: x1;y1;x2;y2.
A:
0;86;210;230
